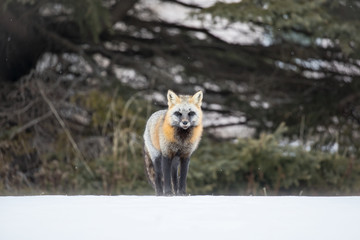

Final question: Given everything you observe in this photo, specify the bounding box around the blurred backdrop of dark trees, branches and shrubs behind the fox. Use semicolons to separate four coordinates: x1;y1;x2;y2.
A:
0;0;360;195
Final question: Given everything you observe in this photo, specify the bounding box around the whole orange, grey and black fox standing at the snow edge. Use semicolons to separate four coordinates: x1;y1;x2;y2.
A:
144;90;203;195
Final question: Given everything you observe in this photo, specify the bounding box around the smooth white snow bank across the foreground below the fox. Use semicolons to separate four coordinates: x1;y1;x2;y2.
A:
0;196;360;240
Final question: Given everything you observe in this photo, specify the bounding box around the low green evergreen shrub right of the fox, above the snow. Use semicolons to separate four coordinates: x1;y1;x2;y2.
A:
188;125;360;195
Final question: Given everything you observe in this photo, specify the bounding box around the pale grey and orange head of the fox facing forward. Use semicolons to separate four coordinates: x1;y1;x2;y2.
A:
167;90;203;130
